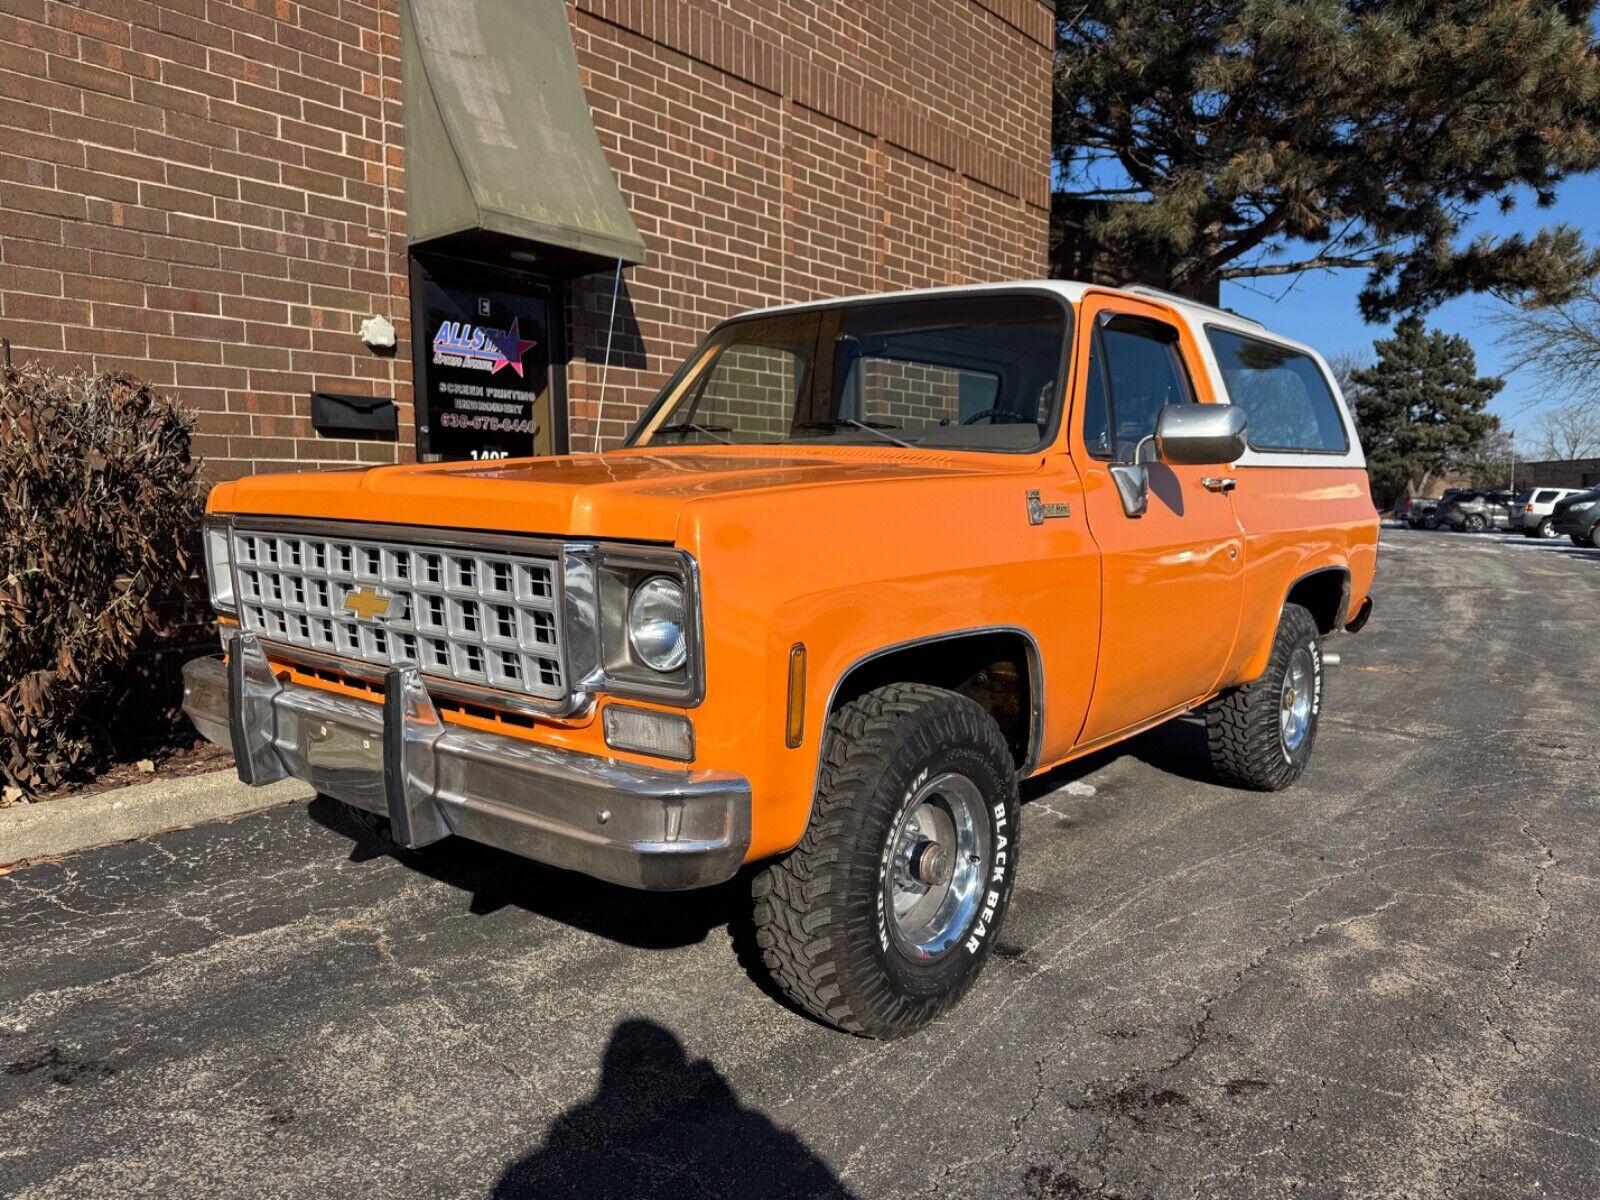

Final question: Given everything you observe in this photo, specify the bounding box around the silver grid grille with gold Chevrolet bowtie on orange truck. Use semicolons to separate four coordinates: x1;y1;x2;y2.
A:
234;528;566;699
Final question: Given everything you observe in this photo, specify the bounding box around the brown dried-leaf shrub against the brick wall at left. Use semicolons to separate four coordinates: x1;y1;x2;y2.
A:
0;363;205;792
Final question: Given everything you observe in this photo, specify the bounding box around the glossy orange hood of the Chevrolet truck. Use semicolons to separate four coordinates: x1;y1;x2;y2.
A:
206;446;1011;542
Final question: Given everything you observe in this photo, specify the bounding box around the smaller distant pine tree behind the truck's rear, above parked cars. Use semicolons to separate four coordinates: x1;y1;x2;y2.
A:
1350;317;1504;502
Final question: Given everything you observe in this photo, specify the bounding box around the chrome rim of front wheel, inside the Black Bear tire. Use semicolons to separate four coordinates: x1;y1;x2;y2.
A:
885;771;992;960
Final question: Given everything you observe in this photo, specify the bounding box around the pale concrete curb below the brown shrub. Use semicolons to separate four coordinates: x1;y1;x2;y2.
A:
0;766;317;866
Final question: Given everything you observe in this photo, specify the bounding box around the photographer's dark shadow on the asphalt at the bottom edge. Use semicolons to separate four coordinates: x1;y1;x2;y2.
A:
490;1019;850;1200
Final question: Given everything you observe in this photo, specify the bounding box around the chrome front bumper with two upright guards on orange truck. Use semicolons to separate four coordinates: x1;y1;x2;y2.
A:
184;634;750;891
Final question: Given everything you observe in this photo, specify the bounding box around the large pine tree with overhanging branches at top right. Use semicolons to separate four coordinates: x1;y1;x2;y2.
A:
1054;0;1600;320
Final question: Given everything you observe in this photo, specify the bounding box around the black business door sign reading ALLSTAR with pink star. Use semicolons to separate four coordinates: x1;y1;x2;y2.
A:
414;262;552;459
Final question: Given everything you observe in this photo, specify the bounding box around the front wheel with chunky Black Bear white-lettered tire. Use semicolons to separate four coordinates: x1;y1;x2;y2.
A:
752;683;1018;1038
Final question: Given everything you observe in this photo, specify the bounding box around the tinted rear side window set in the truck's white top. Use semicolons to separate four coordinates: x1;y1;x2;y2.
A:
1206;328;1350;454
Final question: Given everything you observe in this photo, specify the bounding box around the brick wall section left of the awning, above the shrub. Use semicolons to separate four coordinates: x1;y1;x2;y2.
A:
0;0;411;478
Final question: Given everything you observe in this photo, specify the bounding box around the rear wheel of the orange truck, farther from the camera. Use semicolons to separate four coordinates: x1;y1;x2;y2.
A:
1205;605;1322;792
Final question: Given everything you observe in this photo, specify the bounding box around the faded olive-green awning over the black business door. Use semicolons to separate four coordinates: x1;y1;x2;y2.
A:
400;0;645;274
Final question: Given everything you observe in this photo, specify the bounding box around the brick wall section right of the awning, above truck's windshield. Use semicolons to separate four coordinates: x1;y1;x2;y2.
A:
568;0;1054;450
